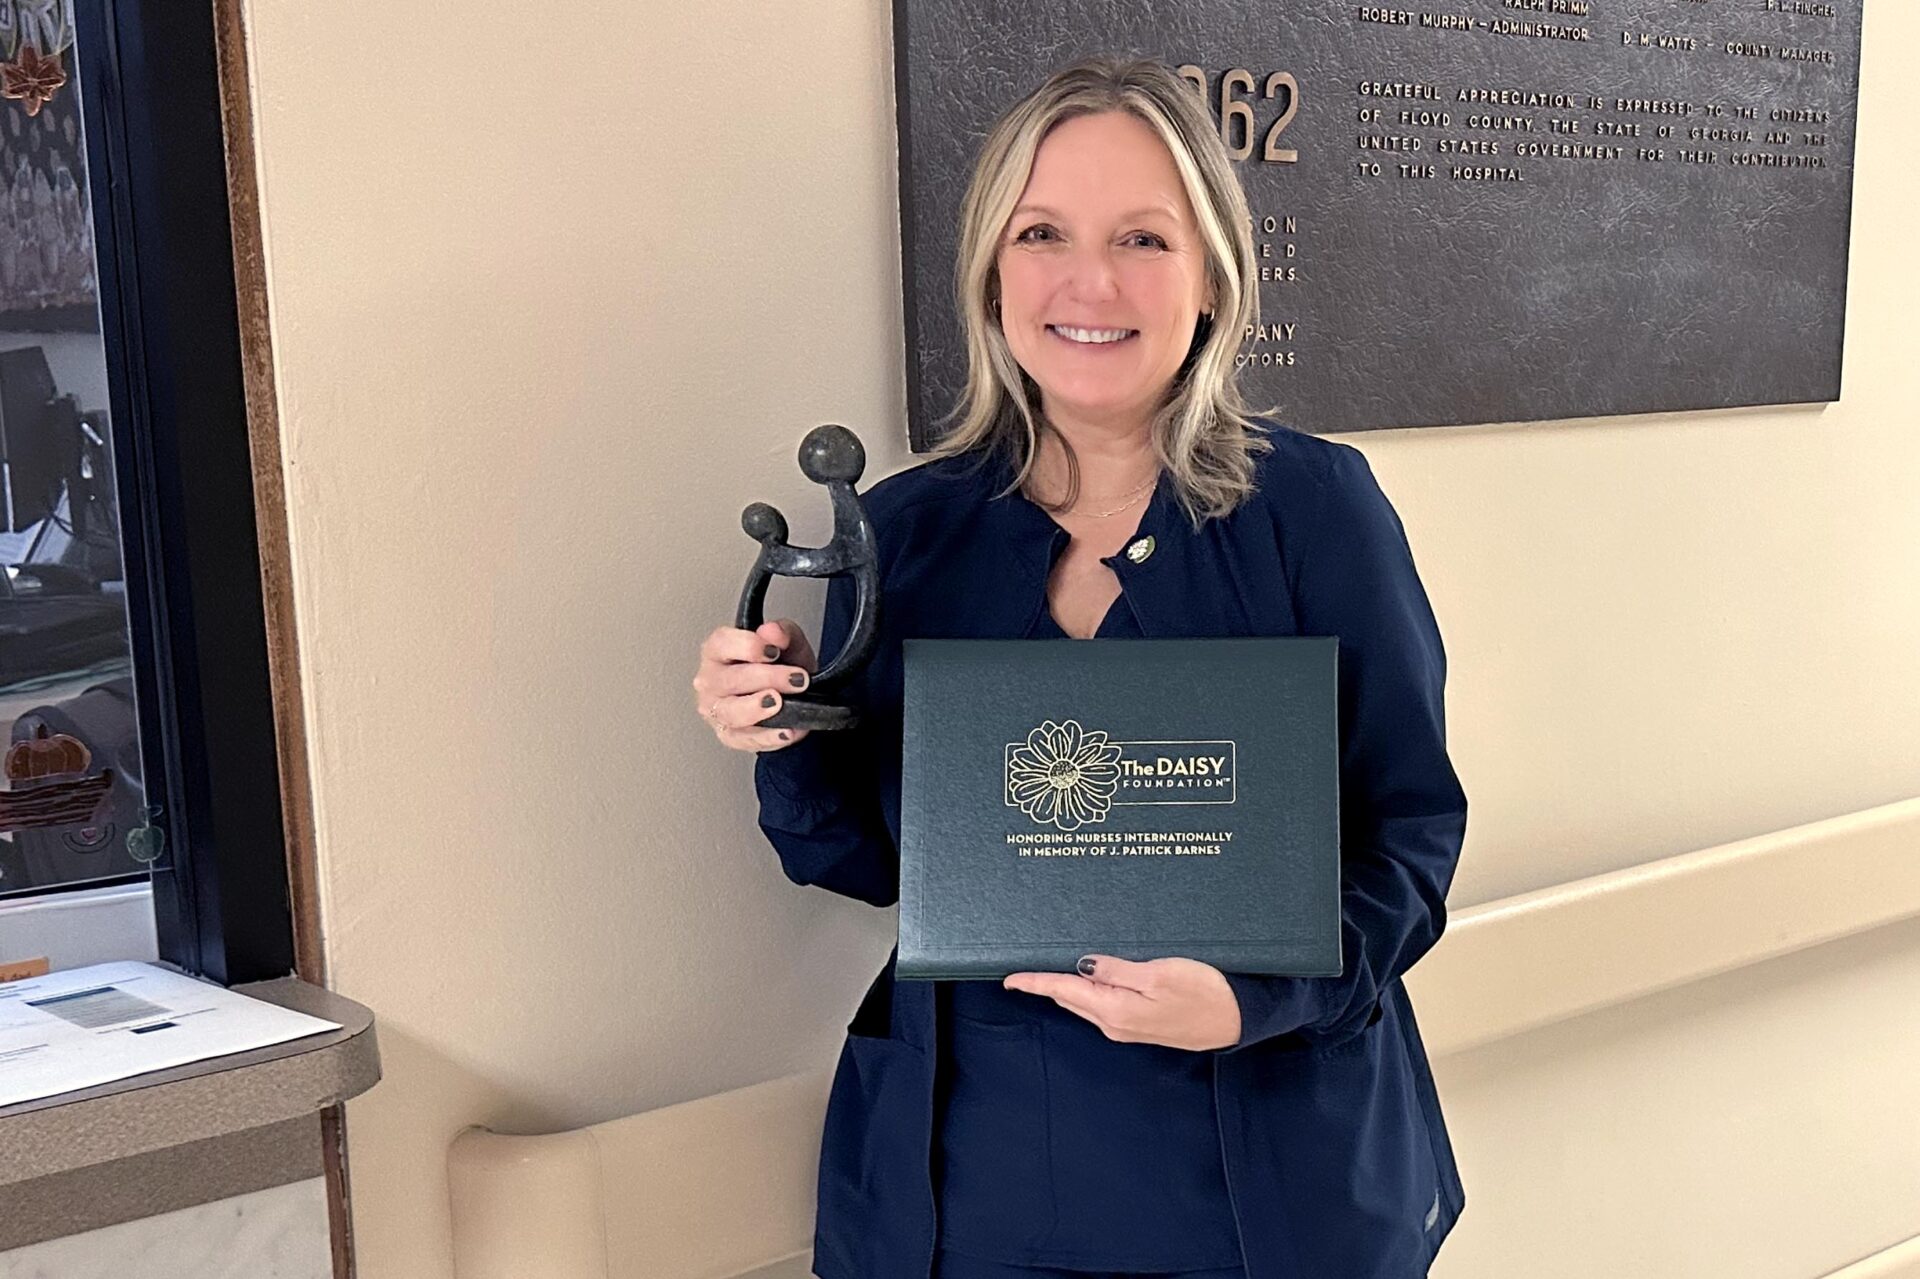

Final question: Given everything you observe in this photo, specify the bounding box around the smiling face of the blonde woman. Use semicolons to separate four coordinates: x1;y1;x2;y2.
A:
996;111;1212;426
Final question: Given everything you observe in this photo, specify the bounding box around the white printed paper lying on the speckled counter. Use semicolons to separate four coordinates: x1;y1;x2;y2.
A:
0;960;340;1106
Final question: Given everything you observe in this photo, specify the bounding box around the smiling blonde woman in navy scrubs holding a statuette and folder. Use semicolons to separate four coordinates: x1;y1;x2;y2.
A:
693;60;1467;1279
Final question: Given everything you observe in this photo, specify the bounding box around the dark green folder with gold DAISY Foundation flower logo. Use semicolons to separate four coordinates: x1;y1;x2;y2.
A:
897;636;1340;979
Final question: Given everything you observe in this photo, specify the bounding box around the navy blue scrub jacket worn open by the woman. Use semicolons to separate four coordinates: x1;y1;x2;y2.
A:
755;419;1467;1279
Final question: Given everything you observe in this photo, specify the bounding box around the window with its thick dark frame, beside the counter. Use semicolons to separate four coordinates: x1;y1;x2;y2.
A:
0;0;294;983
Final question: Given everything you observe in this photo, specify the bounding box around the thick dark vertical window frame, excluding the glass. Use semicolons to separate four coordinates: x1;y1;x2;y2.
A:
71;0;296;985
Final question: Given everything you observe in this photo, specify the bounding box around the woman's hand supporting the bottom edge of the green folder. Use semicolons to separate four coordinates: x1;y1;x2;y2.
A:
1000;954;1240;1052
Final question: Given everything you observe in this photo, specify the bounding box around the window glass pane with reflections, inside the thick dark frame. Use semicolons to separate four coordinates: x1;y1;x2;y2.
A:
0;0;159;899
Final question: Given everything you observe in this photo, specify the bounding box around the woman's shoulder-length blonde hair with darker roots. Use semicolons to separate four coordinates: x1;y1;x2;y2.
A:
929;56;1273;528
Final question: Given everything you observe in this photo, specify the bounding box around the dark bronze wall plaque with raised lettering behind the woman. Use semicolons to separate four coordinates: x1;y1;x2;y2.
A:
895;0;1860;441
